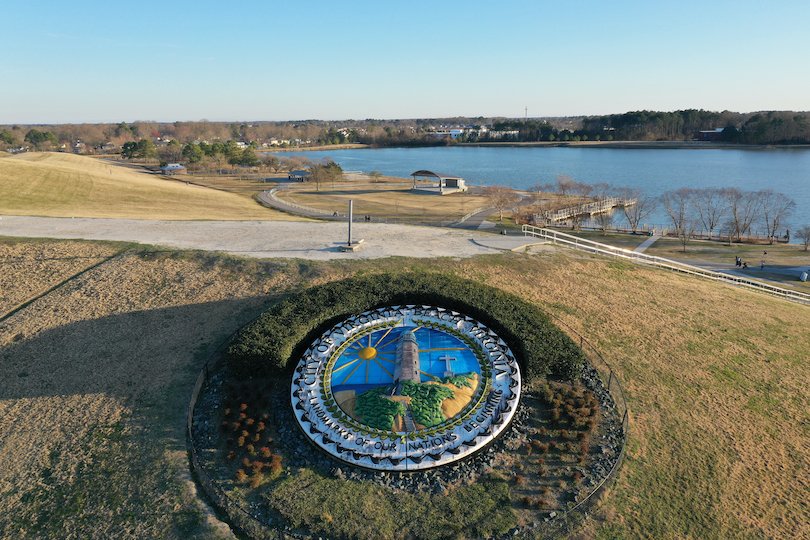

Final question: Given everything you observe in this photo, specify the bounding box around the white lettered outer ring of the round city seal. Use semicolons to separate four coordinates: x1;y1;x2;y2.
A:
290;305;521;472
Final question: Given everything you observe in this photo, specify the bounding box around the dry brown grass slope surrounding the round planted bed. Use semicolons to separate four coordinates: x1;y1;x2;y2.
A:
0;241;810;539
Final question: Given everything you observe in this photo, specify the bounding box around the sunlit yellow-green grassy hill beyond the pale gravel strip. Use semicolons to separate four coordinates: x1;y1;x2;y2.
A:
0;153;304;220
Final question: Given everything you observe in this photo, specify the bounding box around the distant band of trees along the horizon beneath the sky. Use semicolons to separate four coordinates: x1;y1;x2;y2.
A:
6;109;810;152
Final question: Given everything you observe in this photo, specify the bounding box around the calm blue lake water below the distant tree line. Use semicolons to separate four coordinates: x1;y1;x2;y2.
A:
282;147;810;233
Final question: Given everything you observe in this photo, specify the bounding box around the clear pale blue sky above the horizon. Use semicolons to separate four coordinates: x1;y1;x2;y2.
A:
0;0;810;124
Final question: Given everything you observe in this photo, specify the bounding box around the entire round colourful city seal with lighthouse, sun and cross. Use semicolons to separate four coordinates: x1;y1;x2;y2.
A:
291;305;520;471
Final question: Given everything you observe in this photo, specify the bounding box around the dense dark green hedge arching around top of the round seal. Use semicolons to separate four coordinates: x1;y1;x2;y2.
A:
225;273;585;382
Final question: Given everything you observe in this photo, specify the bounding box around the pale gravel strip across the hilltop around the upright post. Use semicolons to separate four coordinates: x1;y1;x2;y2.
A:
0;216;507;260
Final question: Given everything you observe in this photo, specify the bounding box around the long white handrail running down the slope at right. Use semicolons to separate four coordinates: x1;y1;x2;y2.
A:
523;225;810;304
